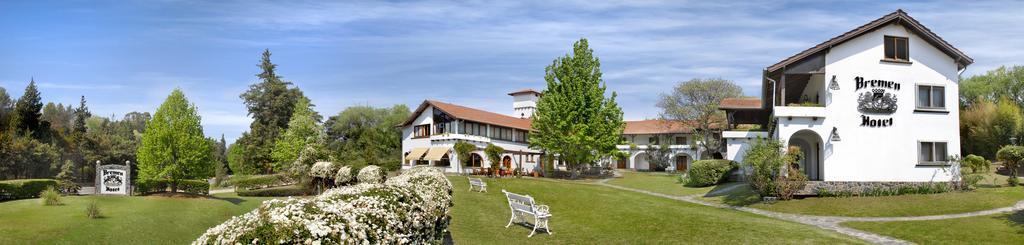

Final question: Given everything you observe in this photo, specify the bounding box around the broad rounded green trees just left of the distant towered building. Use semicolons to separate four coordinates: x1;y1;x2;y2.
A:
324;105;412;169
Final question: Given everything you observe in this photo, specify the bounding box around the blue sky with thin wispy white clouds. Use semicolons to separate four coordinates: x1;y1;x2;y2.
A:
0;0;1024;141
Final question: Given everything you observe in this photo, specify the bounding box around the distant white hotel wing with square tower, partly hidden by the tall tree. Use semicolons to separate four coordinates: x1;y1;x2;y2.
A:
399;89;699;172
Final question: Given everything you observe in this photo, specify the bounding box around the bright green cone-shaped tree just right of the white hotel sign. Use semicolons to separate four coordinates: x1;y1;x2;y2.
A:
138;89;213;192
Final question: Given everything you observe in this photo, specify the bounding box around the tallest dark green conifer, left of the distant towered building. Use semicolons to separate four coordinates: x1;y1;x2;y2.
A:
236;50;305;173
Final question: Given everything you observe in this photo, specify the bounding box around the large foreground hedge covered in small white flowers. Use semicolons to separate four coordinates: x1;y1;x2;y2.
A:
193;167;452;244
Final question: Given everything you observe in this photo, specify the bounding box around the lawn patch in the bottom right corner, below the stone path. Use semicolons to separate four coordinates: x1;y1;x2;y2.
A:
843;211;1024;244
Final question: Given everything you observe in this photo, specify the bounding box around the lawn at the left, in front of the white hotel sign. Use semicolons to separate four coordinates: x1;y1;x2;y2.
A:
0;194;270;244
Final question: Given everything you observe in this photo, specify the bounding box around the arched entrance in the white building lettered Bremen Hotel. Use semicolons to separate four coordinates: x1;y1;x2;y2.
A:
788;130;824;180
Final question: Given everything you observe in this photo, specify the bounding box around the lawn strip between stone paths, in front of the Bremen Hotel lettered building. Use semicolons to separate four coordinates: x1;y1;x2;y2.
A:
750;188;1024;216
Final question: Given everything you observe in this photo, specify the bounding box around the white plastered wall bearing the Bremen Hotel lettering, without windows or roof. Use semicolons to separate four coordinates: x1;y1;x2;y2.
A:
774;25;959;181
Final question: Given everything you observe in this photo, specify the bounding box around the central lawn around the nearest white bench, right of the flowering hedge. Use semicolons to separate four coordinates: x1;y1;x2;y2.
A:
450;176;862;244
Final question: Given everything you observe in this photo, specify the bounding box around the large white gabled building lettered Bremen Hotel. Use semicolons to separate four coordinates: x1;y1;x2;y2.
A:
721;10;973;182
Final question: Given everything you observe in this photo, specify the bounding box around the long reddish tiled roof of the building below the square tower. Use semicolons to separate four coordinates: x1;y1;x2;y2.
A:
400;99;532;130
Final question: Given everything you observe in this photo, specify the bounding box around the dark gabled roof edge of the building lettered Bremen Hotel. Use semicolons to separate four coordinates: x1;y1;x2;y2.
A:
767;9;974;72
